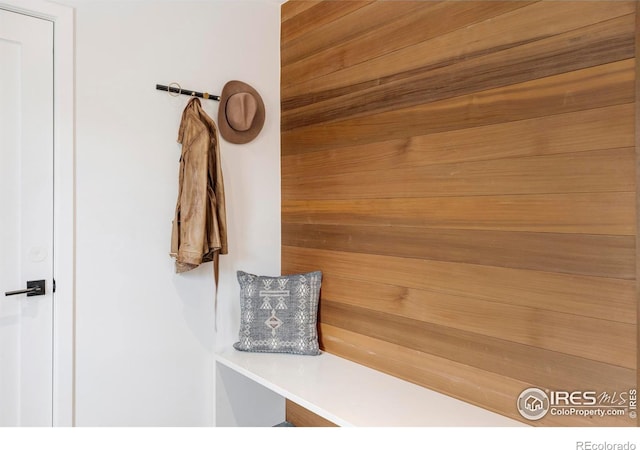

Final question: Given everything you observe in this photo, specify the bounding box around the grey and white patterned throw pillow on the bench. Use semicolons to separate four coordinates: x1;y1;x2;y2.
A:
233;271;322;355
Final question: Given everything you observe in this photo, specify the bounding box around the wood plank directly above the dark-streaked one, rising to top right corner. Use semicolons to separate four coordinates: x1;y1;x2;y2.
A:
282;1;635;100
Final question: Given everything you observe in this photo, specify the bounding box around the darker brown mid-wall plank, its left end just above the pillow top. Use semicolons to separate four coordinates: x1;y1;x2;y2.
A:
282;223;635;279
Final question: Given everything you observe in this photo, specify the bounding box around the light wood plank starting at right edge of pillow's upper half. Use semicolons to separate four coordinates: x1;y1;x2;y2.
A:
320;300;635;376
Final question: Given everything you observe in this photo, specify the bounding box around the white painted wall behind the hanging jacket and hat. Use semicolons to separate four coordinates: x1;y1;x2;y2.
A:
60;0;280;426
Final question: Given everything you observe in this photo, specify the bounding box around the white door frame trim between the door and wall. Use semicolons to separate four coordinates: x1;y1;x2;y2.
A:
0;0;75;426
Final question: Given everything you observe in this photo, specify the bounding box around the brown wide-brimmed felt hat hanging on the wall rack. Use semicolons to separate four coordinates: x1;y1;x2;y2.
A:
218;80;265;144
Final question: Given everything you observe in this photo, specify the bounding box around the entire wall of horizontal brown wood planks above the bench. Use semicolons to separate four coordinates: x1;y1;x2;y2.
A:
281;1;638;426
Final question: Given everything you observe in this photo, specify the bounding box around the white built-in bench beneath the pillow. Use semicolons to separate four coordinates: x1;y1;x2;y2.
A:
216;349;526;427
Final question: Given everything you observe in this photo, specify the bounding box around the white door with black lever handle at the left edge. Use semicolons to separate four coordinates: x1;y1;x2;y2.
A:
0;10;53;426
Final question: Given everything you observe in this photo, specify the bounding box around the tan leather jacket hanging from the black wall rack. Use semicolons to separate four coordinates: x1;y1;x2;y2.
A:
171;97;228;273
